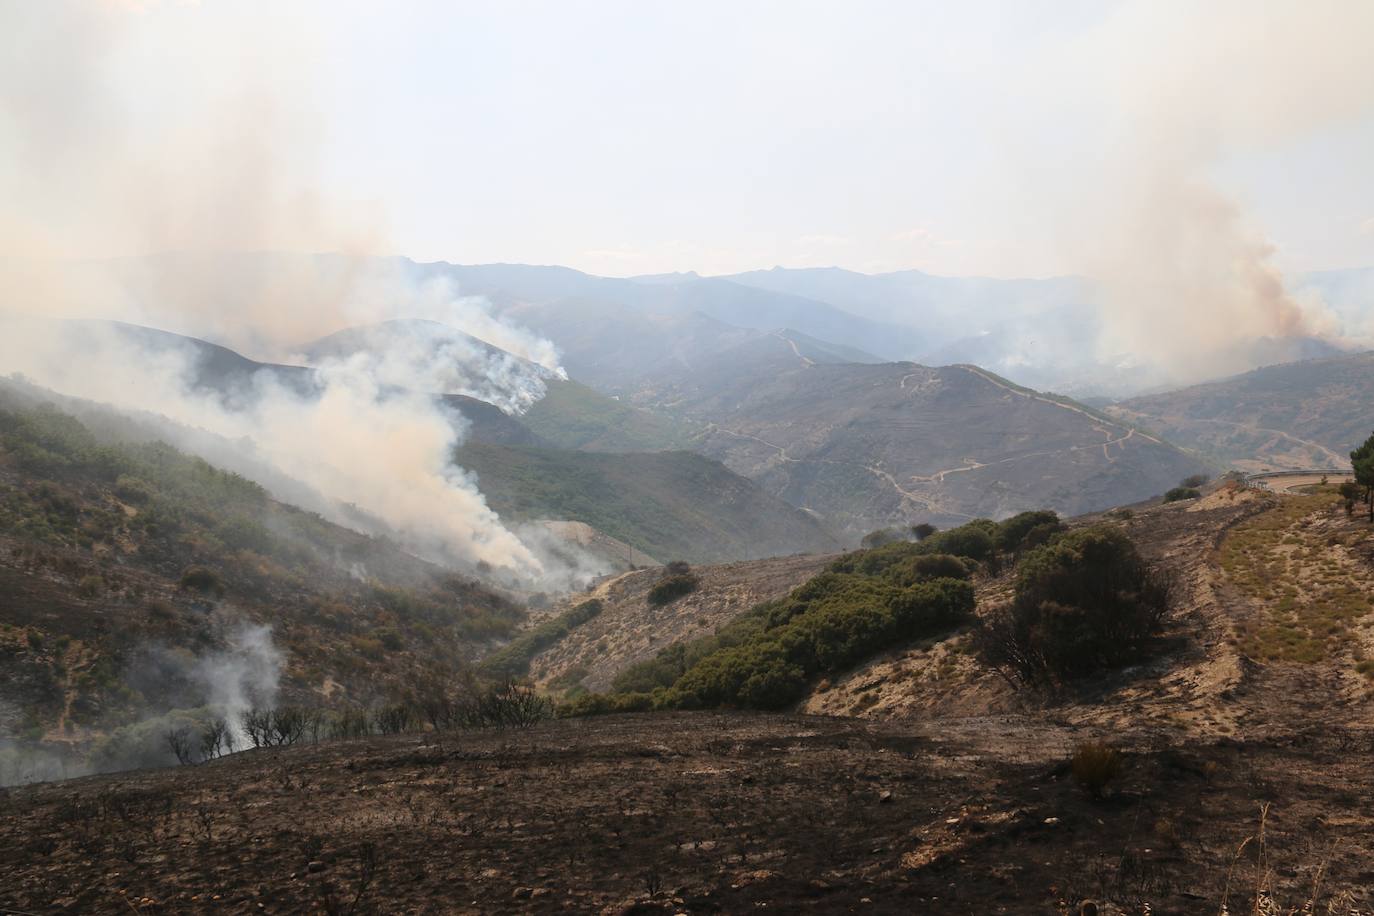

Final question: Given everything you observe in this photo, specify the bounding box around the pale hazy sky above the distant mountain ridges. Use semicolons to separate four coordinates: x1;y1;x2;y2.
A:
0;0;1374;276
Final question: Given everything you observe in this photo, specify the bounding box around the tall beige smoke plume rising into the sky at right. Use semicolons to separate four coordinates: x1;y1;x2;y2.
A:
1041;1;1374;382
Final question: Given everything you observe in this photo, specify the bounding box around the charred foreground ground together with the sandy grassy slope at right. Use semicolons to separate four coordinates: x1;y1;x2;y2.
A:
0;492;1374;913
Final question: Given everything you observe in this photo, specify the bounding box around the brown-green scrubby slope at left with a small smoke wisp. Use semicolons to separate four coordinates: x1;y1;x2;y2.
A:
0;382;525;781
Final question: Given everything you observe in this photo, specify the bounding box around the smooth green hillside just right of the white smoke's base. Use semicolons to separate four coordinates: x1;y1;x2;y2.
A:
458;442;837;563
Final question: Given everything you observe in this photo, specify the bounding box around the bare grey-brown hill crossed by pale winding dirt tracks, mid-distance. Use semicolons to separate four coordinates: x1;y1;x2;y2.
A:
658;363;1202;537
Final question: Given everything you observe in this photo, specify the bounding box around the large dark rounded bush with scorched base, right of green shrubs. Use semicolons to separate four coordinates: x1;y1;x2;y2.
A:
977;526;1169;683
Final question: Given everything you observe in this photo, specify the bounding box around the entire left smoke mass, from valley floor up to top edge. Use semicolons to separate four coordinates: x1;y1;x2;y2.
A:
0;0;561;574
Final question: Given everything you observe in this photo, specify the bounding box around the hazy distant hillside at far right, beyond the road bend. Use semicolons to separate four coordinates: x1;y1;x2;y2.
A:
1107;352;1374;471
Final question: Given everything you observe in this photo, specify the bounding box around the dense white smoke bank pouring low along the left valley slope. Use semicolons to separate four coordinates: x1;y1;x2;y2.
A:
0;313;540;575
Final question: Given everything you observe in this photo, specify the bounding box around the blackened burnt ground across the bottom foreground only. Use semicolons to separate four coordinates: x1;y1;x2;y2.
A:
0;713;1374;913
